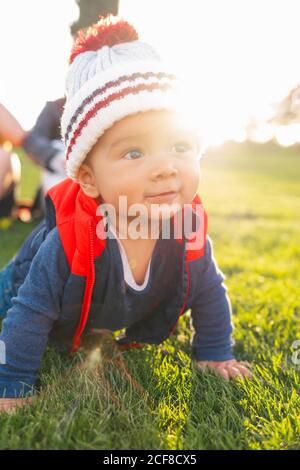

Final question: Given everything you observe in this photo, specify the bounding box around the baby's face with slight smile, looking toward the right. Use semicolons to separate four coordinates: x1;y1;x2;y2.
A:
81;110;200;225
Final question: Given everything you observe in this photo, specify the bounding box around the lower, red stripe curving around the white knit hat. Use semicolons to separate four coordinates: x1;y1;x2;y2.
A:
66;83;172;160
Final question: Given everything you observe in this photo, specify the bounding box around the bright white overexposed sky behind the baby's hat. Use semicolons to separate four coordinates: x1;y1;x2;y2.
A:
0;0;300;145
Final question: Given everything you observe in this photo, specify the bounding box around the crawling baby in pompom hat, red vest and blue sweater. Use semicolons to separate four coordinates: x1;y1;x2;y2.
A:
0;16;251;411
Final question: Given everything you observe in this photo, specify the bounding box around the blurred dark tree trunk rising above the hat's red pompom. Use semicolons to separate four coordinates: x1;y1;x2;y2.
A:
70;0;119;36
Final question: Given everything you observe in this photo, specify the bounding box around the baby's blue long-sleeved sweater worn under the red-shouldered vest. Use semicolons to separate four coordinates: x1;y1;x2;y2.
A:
0;226;234;397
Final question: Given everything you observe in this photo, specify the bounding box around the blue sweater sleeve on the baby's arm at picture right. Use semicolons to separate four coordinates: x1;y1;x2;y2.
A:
191;235;234;361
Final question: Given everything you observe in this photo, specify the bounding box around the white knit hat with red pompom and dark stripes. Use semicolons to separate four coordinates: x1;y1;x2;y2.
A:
61;15;189;180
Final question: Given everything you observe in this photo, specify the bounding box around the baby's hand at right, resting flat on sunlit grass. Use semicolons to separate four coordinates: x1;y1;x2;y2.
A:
196;359;252;380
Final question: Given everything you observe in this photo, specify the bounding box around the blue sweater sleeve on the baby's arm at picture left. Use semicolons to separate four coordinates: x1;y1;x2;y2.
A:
0;228;69;398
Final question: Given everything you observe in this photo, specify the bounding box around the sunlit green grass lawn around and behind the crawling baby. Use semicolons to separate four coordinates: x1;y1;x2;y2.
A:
0;143;300;450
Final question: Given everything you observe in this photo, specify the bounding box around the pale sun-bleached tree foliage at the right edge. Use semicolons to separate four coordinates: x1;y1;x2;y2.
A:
270;84;300;125
